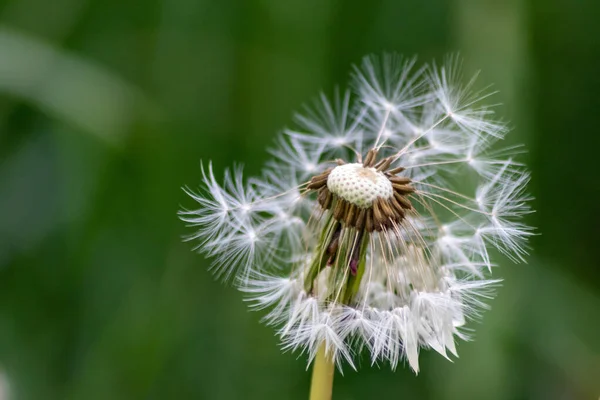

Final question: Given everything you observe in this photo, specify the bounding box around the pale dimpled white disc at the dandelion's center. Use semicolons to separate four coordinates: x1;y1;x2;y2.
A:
327;163;394;208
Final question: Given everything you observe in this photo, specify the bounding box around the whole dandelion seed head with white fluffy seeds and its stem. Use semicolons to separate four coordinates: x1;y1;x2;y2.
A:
180;54;532;398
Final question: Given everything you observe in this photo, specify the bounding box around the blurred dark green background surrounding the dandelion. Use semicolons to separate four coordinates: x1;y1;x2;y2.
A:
0;0;600;400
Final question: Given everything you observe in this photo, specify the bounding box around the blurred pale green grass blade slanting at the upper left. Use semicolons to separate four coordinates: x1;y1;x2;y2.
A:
0;26;150;143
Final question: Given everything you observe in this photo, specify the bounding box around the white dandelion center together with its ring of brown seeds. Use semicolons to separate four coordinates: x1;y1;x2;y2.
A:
307;149;415;233
